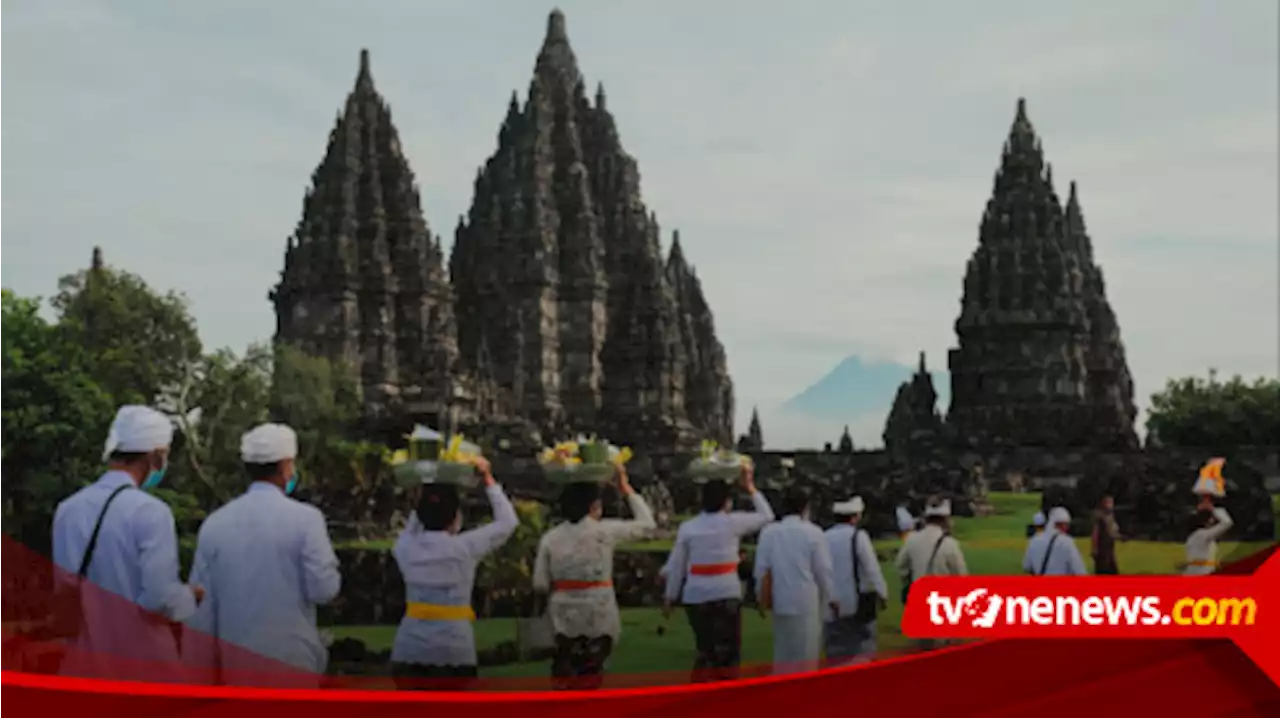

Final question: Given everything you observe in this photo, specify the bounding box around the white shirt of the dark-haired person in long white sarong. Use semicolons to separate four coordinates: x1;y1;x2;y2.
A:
755;516;836;616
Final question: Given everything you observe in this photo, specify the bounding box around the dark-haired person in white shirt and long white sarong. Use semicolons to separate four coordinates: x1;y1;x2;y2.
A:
755;488;840;673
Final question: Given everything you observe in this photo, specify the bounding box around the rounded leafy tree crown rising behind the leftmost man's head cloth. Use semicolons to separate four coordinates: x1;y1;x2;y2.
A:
52;258;201;404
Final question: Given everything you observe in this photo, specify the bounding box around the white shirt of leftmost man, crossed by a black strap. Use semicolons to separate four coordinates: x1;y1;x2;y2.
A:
52;471;196;681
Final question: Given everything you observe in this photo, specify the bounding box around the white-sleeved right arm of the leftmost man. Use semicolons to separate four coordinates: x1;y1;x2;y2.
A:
133;500;196;622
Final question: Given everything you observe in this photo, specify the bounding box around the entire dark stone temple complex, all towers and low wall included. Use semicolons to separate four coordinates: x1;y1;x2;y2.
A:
270;12;1275;540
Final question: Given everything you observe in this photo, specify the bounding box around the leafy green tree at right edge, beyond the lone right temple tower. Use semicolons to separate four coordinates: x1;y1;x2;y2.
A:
1147;370;1280;452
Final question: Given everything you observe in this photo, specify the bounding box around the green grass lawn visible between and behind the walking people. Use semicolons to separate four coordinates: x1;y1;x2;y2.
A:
333;494;1266;677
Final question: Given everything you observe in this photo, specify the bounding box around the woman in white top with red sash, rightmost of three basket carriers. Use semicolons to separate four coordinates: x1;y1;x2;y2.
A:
663;466;773;682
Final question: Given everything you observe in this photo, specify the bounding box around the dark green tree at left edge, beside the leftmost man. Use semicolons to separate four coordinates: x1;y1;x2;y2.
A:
0;289;113;550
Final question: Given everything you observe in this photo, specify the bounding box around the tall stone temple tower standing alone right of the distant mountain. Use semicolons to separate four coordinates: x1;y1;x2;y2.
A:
947;100;1137;447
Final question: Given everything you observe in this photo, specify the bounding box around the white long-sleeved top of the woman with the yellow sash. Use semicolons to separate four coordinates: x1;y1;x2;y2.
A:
392;484;520;666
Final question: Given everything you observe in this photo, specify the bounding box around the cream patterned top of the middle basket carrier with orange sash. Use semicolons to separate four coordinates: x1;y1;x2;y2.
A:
534;493;657;641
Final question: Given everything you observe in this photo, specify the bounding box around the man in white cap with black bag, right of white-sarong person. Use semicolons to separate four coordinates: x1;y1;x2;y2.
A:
823;497;888;663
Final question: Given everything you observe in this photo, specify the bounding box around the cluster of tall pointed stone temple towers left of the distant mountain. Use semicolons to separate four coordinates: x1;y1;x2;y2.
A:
271;12;733;452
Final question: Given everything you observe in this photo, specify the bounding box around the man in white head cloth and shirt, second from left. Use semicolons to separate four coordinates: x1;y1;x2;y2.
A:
184;424;342;686
